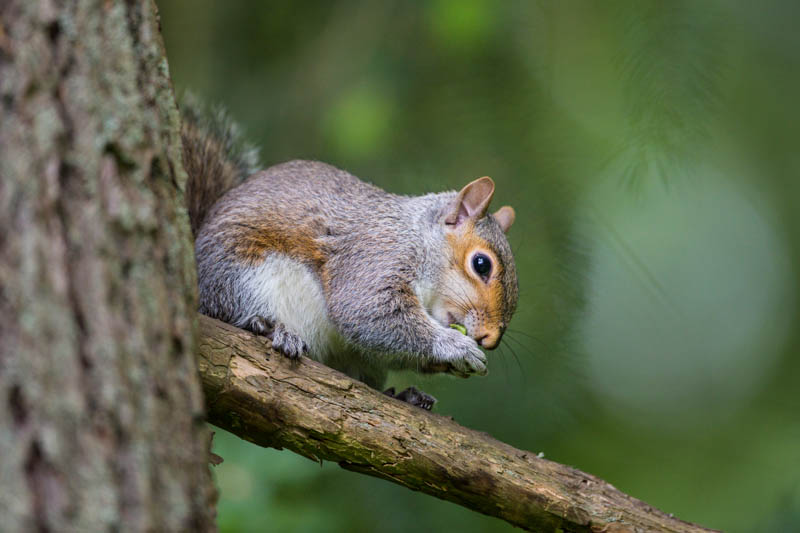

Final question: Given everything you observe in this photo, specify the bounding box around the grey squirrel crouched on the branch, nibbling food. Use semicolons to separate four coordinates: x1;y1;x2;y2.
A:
181;97;518;410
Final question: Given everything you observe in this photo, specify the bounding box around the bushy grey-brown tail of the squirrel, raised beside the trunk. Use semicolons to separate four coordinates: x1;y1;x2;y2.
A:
180;93;260;235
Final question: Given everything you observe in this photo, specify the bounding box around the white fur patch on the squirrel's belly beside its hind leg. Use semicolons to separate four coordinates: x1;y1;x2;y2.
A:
234;253;344;362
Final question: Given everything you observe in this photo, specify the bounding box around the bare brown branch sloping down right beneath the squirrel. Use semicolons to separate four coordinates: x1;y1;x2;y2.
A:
198;315;710;532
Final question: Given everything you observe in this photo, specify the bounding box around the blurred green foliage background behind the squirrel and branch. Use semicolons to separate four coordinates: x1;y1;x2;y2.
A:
158;0;800;532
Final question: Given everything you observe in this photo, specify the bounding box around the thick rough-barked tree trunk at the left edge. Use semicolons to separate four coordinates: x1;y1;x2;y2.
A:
0;0;215;531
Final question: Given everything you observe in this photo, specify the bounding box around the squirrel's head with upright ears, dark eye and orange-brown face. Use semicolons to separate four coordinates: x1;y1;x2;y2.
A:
431;177;519;350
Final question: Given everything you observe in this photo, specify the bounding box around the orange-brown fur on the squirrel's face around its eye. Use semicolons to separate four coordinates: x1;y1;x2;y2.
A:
447;222;504;349
